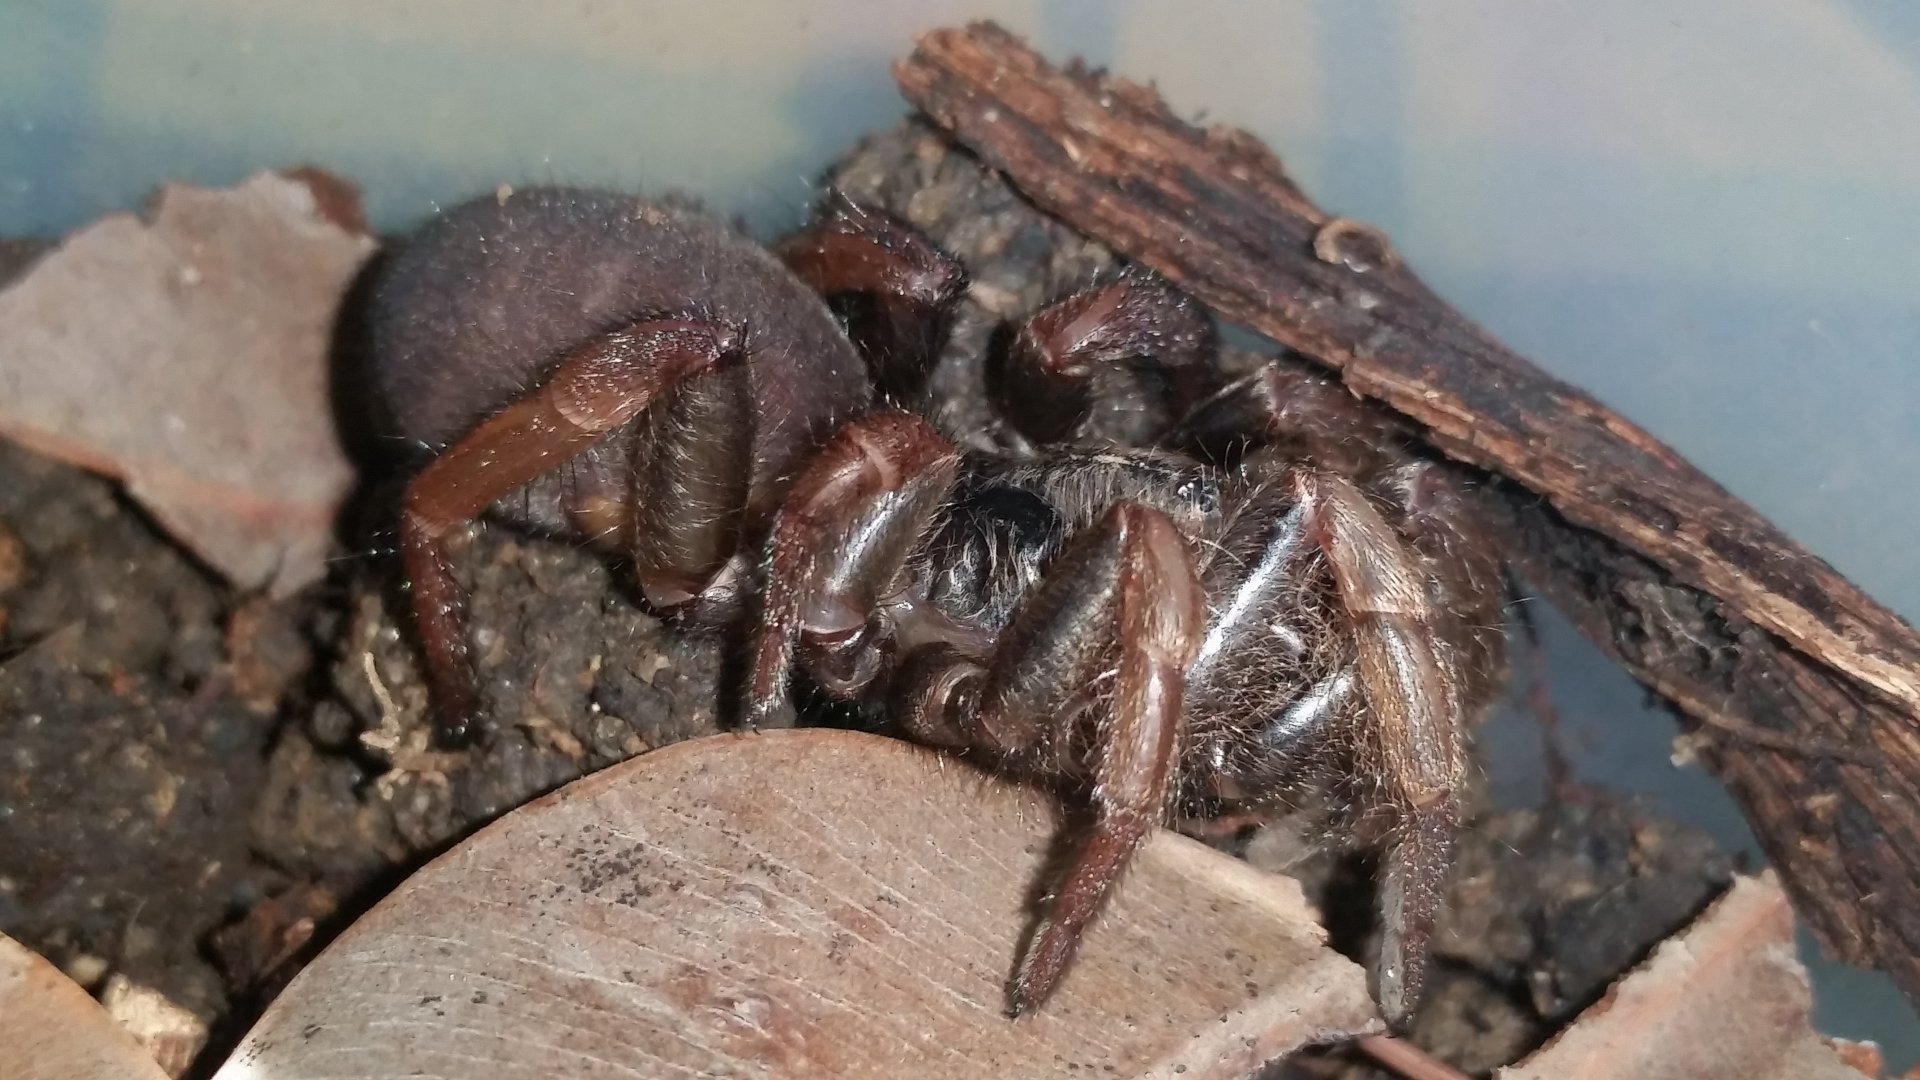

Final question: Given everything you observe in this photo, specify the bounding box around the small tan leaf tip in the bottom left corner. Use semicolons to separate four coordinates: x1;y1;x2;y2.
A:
0;934;167;1080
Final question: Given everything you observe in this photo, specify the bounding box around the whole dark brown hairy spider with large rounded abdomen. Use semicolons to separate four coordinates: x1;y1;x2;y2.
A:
371;188;1503;1020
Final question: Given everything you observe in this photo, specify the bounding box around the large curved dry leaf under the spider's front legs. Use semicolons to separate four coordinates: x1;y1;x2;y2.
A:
219;730;1377;1080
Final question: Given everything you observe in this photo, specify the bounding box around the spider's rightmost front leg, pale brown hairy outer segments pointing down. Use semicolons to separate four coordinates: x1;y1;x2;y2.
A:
1294;471;1467;1024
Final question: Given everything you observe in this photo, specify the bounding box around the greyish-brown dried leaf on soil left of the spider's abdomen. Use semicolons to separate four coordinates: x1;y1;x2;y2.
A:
0;173;374;594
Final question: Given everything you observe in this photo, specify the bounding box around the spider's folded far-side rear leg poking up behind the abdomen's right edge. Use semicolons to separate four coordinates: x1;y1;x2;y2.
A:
776;194;968;404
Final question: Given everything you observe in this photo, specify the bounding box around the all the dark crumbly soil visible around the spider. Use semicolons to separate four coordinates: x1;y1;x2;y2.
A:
0;123;1730;1076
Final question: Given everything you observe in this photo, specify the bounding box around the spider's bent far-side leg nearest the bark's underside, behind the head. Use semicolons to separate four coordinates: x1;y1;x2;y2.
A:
989;269;1213;442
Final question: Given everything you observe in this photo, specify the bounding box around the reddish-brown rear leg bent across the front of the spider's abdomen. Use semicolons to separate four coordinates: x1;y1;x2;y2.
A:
399;319;741;744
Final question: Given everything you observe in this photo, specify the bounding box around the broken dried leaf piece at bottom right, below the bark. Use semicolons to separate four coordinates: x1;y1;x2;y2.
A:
1496;871;1860;1080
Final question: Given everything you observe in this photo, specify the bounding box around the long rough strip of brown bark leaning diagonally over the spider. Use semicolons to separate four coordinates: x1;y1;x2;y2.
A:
895;25;1920;999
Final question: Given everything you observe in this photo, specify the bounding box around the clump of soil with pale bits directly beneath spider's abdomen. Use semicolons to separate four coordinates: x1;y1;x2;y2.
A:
266;515;744;878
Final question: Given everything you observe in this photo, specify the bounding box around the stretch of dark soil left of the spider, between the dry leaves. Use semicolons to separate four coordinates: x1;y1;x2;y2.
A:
0;430;722;1022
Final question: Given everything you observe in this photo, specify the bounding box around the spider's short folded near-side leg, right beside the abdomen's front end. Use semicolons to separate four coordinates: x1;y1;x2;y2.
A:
747;409;960;724
